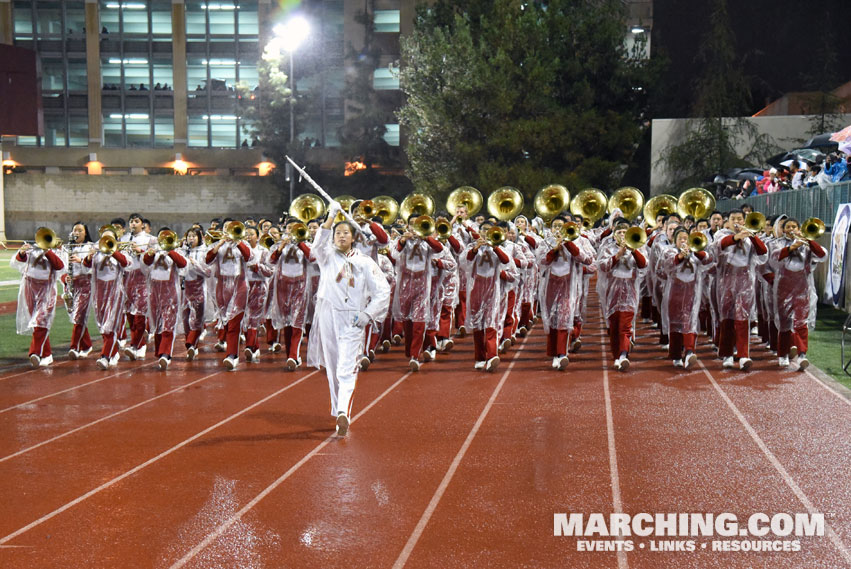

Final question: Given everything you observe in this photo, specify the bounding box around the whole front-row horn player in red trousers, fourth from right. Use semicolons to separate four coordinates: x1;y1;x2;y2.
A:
597;218;647;371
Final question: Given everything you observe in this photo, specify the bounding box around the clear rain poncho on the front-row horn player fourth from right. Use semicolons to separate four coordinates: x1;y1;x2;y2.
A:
596;239;647;318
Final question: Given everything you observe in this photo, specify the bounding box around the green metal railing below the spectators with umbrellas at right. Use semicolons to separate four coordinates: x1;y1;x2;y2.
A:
717;182;851;227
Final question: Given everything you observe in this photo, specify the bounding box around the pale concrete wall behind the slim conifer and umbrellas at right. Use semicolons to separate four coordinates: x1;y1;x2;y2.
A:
650;114;851;196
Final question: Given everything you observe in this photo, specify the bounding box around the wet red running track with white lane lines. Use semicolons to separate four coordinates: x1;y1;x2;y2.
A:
0;290;851;569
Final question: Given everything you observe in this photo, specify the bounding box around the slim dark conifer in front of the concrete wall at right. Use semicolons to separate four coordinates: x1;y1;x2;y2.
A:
661;0;779;189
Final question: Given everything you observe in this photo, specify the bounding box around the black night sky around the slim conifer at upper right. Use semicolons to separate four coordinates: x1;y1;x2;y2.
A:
652;0;851;118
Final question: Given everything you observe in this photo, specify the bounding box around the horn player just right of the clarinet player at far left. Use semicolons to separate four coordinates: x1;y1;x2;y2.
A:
83;229;130;370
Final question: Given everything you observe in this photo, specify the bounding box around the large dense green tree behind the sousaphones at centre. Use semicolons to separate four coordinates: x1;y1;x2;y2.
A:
398;0;654;204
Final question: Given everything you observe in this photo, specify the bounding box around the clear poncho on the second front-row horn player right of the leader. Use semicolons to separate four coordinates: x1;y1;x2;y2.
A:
459;243;517;331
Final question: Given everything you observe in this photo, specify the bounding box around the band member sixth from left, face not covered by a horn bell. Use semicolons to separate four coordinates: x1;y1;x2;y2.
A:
182;229;213;362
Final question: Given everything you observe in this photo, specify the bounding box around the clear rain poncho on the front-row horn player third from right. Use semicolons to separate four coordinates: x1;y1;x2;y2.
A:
656;247;712;334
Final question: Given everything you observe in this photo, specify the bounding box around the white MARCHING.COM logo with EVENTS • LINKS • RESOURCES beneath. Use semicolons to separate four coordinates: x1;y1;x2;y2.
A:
553;512;825;551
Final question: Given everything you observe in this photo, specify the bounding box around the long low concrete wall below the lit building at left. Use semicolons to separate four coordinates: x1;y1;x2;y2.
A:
5;173;288;239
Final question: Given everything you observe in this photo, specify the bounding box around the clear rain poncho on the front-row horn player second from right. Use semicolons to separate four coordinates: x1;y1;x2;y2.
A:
709;229;767;321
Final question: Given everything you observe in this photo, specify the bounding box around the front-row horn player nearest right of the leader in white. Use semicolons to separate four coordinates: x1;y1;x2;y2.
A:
393;215;443;371
